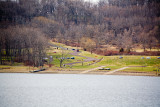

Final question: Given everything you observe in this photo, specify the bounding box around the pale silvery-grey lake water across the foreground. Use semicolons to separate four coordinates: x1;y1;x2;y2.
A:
0;73;160;107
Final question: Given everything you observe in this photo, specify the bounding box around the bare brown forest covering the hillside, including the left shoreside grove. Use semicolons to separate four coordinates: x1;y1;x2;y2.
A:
0;0;160;66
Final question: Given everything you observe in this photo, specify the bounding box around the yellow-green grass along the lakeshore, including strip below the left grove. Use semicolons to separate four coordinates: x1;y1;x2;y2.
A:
0;43;160;75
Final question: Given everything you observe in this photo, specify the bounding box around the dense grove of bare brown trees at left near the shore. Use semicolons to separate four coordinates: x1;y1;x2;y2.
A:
0;26;47;67
